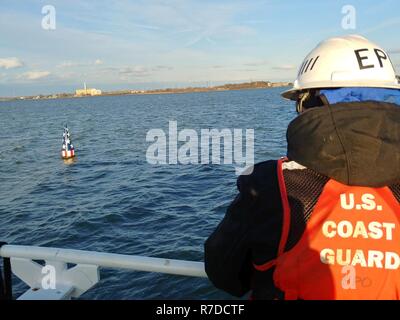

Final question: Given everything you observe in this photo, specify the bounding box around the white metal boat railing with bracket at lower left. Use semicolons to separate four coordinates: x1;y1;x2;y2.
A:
0;245;207;300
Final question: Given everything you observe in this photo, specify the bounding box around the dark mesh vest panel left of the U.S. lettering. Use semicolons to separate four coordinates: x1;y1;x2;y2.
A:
283;169;329;251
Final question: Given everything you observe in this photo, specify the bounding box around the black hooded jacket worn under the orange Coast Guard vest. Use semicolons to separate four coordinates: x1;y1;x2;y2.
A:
205;102;400;299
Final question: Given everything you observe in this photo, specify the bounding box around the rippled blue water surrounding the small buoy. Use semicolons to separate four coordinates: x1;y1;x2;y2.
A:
0;89;295;299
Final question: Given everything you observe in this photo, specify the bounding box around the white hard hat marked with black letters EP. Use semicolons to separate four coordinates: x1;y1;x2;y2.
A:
282;35;400;100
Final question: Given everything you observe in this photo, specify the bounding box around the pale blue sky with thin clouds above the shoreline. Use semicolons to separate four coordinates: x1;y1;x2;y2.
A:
0;0;400;96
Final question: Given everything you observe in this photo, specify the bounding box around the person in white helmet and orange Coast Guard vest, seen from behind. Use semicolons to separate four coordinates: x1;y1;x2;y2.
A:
205;35;400;299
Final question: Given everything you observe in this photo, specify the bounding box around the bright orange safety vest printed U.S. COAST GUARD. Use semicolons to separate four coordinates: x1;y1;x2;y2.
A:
254;160;400;300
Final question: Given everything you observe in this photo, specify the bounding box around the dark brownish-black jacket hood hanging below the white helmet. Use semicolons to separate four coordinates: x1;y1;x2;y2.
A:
287;102;400;188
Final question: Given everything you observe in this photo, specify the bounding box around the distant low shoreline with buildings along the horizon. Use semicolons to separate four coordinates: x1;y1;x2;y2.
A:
0;81;292;101
